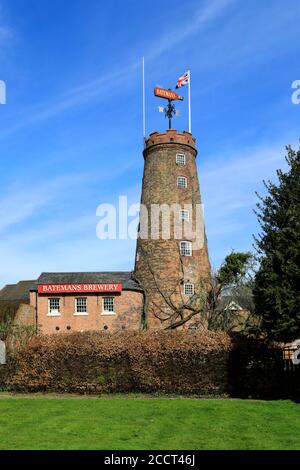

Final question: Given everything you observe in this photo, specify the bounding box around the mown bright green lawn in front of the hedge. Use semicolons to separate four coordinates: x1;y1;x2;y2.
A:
0;396;300;450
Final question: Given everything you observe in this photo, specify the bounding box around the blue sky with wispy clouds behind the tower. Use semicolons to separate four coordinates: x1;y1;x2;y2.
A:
0;0;300;286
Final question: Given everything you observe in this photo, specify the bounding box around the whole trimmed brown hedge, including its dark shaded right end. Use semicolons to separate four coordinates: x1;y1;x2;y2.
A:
0;331;288;398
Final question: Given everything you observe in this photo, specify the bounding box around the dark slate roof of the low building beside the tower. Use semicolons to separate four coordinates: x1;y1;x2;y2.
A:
30;271;142;292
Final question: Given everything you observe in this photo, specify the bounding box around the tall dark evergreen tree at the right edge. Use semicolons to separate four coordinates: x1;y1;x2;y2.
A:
254;146;300;341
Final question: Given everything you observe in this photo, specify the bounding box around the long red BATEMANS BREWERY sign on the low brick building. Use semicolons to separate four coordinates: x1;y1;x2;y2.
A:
38;284;122;294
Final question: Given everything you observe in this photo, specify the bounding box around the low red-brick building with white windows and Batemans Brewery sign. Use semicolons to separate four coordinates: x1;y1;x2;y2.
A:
30;272;143;334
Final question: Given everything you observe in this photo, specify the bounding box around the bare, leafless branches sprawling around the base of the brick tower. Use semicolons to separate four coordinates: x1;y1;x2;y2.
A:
136;247;252;331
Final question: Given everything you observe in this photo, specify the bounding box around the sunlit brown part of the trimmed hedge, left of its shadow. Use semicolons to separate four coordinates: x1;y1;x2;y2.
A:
0;331;232;395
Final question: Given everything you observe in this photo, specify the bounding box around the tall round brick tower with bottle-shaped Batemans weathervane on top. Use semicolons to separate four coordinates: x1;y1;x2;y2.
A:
134;83;210;329
